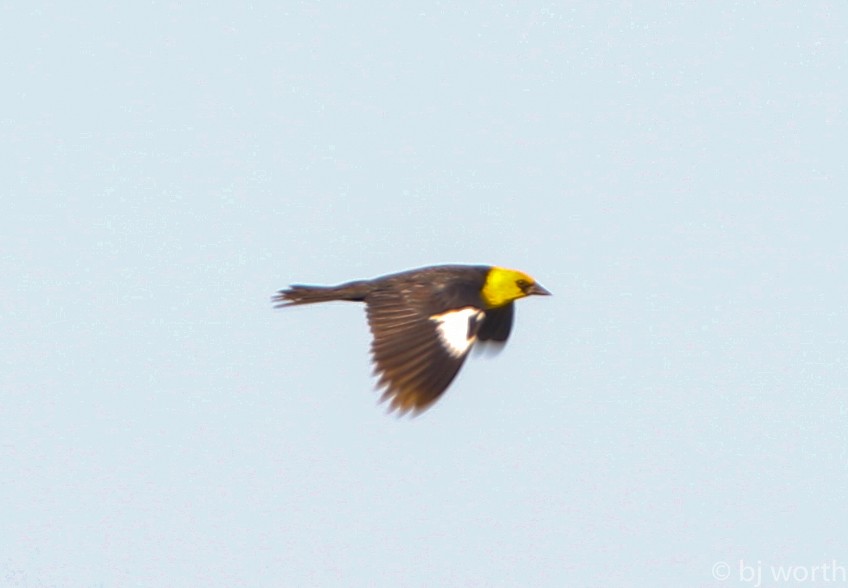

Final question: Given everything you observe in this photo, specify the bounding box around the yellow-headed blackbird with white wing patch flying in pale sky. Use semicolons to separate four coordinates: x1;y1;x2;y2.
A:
272;265;551;415
